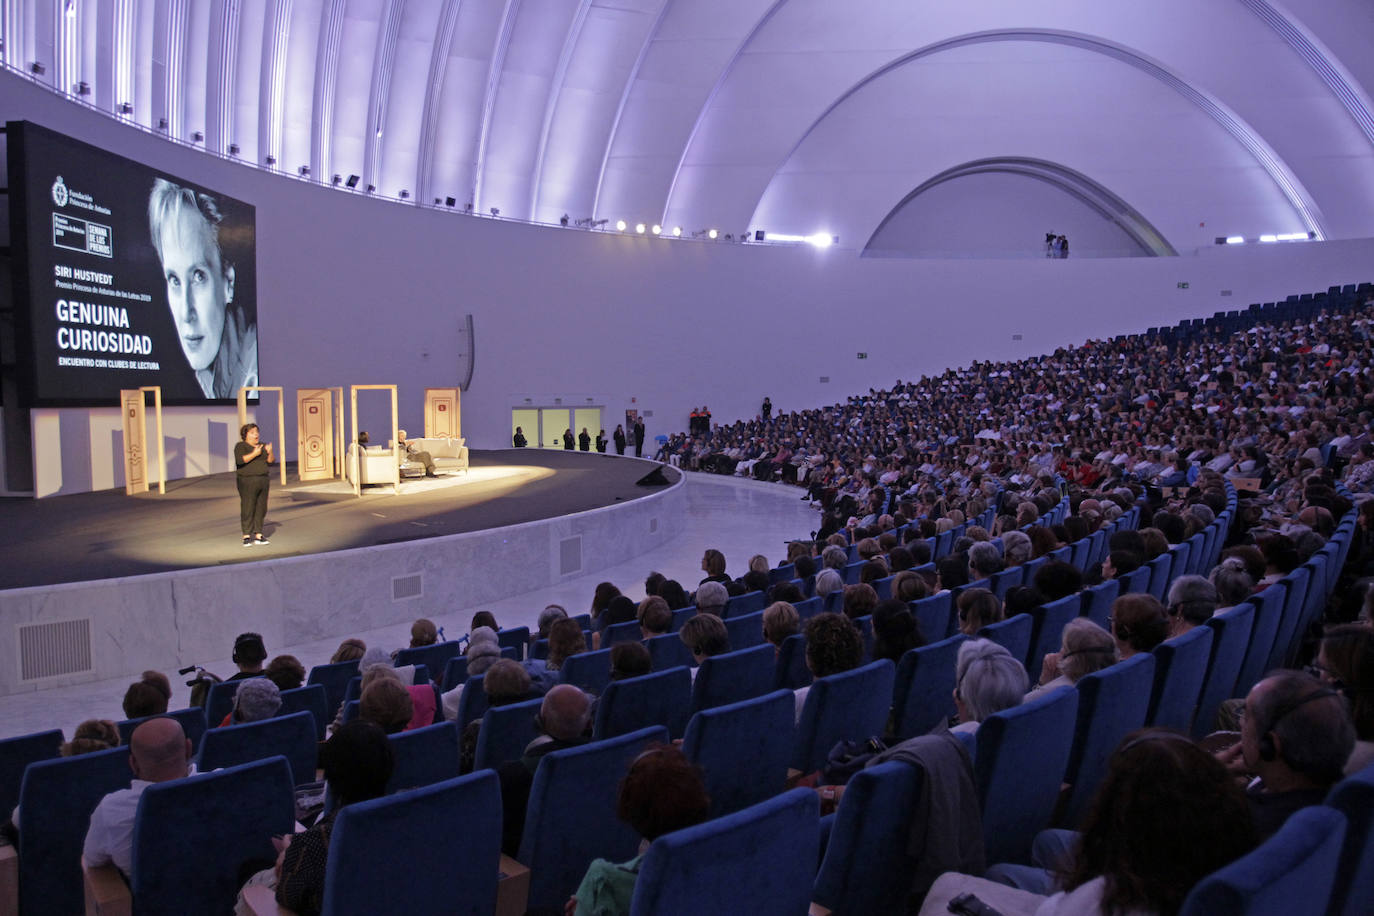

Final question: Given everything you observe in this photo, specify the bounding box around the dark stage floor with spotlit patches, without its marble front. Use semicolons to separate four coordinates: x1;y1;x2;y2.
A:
0;449;679;588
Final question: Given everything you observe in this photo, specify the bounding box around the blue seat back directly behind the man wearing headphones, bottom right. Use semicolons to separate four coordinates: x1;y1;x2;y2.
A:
1179;805;1346;916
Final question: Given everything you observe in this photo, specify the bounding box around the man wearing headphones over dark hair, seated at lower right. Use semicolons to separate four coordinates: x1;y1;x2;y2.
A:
1217;670;1355;842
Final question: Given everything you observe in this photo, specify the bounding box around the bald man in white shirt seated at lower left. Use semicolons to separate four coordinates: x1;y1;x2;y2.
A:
81;715;195;878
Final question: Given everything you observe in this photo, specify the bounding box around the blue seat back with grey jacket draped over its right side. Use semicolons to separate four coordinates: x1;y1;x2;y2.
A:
812;761;925;913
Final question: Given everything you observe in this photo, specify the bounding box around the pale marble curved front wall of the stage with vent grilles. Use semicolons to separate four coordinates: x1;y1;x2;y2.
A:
0;461;687;696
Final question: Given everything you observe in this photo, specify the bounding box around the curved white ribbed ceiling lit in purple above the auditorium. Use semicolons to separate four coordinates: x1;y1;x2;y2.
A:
10;0;1374;250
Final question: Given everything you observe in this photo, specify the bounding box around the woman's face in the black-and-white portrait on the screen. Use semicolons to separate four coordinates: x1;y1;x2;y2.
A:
161;206;234;372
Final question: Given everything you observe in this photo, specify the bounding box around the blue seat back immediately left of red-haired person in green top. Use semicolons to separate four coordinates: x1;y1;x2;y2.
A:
516;728;667;909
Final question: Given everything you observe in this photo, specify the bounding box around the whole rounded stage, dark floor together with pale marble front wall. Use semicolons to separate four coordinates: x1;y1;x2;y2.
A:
0;449;686;695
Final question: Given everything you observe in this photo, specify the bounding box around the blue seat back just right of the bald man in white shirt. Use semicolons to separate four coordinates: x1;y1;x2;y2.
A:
129;757;295;916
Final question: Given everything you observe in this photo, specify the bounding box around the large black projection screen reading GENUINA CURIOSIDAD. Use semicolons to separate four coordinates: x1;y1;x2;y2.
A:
5;121;258;407
